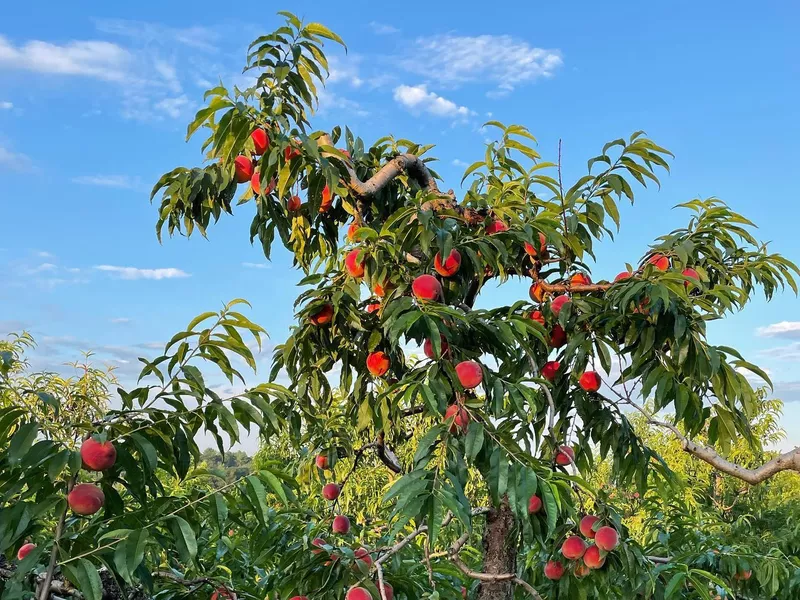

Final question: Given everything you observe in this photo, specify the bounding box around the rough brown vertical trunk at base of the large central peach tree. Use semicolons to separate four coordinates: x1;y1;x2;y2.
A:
478;497;517;600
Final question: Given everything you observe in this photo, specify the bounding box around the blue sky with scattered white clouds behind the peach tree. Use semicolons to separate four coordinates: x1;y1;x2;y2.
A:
0;0;800;445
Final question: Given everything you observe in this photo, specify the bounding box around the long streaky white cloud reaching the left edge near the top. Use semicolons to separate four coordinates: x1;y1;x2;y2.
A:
0;36;131;82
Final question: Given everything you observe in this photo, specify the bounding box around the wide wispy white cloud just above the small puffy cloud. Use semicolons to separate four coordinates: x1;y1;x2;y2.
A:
399;34;563;94
